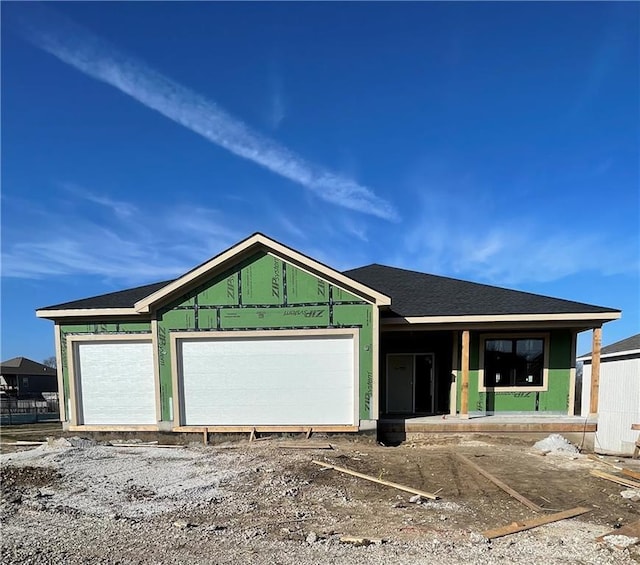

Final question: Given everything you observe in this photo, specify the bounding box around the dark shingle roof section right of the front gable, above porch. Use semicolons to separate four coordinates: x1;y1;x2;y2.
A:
344;264;618;317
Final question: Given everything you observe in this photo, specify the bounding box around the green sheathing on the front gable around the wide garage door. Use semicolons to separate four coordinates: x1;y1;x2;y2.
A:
155;253;375;421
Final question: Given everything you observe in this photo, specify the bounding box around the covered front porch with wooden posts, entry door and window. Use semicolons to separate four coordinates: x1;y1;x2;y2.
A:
379;322;601;420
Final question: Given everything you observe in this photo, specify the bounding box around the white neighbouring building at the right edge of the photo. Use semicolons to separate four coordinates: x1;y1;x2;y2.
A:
578;334;640;455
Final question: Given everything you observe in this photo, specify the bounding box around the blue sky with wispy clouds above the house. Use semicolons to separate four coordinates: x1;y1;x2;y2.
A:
1;2;640;360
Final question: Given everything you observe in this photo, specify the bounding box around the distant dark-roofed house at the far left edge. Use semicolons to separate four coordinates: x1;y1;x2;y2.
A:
0;357;58;399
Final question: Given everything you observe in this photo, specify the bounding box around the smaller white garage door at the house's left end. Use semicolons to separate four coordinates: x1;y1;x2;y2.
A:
76;341;157;425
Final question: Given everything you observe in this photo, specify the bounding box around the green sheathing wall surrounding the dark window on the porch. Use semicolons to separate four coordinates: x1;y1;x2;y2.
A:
457;330;572;413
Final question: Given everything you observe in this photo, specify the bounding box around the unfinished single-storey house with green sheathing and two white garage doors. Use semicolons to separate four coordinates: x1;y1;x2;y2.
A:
37;234;620;431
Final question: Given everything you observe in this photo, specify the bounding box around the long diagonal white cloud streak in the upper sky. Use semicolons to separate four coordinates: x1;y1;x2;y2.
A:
13;3;398;220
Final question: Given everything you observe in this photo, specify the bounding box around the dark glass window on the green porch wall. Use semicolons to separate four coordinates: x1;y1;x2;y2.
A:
484;337;545;388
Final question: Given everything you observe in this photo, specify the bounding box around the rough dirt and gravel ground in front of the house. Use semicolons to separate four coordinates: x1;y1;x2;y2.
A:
0;426;640;565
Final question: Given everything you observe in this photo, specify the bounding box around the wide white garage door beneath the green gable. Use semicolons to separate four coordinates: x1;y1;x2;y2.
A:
181;335;356;426
